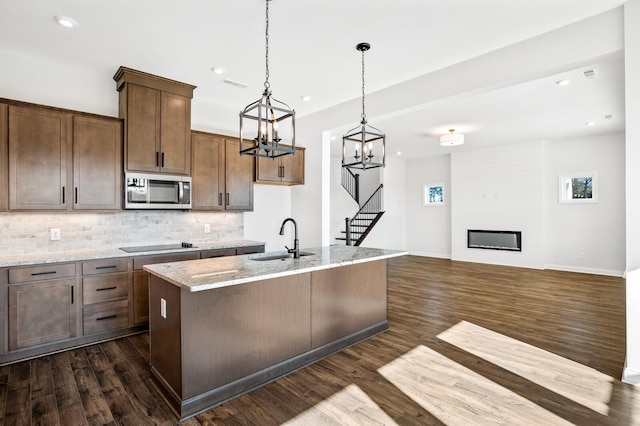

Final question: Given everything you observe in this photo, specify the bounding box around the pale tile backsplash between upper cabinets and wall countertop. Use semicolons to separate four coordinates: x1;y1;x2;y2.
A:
0;210;244;256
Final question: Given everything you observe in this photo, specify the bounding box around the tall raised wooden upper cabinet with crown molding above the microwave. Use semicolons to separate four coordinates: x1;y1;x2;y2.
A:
113;67;195;175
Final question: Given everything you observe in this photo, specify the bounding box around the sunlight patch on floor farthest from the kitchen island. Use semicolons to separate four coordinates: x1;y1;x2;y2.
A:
438;321;613;416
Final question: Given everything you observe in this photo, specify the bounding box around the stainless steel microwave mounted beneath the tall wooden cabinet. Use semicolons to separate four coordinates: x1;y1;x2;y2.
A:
124;173;191;210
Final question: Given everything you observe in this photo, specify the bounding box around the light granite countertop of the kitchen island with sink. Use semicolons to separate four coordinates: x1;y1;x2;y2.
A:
144;246;408;292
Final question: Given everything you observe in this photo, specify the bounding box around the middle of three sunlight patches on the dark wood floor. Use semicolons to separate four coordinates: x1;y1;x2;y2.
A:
378;345;572;426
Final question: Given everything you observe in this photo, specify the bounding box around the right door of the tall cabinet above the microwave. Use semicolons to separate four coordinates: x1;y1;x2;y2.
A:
160;92;191;175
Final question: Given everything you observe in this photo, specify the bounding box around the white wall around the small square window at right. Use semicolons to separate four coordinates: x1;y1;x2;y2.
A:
544;133;625;276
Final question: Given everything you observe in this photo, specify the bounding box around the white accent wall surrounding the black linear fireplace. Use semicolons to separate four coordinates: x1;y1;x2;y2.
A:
450;142;545;269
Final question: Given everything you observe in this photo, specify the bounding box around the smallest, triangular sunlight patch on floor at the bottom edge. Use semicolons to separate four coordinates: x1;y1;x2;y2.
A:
283;385;397;426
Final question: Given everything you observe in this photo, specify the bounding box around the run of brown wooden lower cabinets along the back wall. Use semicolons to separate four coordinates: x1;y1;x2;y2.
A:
0;245;264;365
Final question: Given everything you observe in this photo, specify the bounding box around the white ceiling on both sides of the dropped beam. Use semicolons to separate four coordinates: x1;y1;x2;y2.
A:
0;0;624;158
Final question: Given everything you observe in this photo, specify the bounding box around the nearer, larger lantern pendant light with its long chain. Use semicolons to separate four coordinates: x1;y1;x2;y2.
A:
240;0;296;158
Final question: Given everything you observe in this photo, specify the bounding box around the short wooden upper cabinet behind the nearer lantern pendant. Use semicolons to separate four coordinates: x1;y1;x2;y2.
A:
255;147;305;185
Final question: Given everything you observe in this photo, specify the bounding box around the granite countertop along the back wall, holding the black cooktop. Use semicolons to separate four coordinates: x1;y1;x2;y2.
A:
0;240;265;268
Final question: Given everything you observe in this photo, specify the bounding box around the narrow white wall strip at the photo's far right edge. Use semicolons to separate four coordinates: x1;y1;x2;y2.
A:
624;0;640;385
